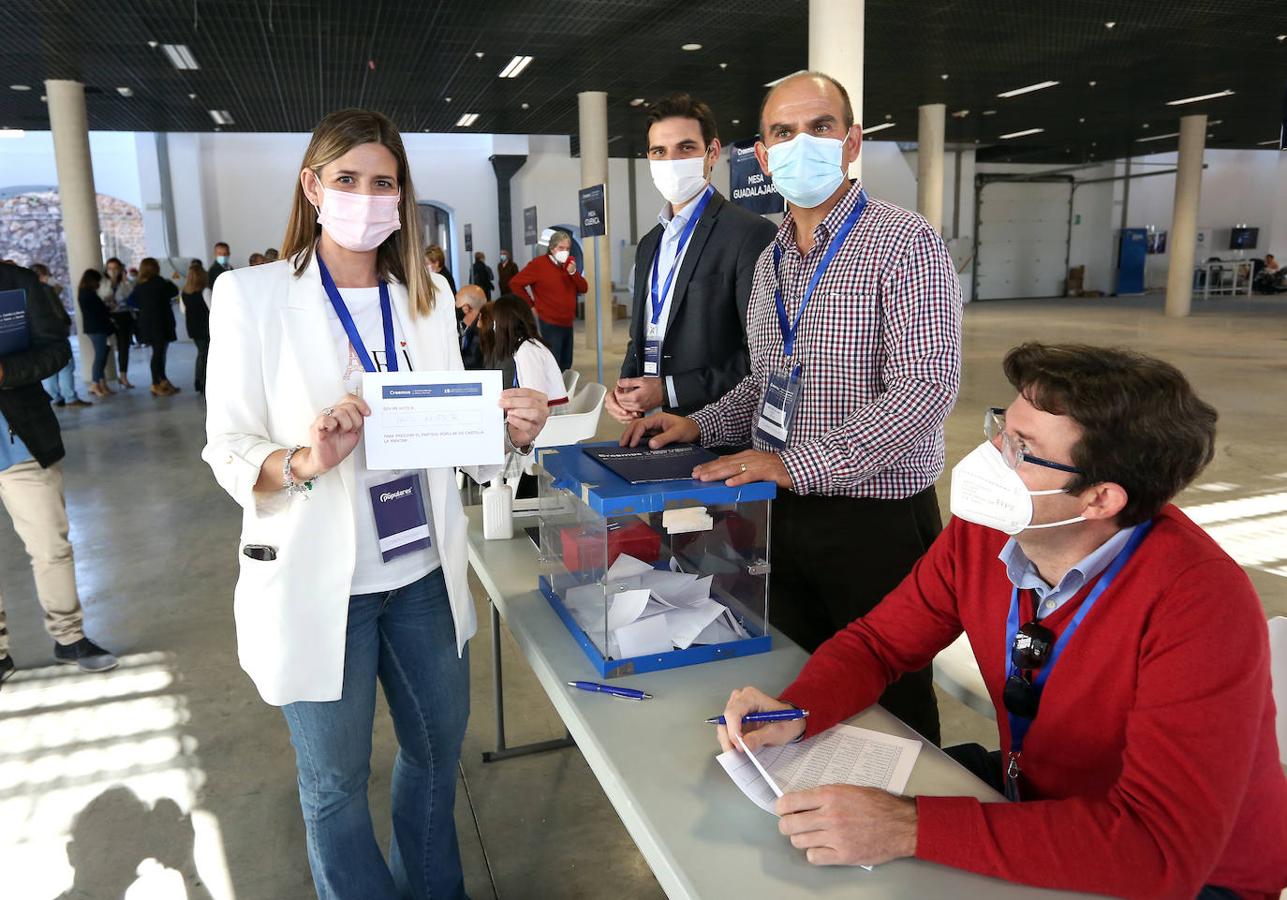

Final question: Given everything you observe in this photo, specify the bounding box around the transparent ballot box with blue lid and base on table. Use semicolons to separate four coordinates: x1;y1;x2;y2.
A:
537;444;776;679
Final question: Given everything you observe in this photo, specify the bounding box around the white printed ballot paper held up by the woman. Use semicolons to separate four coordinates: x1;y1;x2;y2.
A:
362;371;505;469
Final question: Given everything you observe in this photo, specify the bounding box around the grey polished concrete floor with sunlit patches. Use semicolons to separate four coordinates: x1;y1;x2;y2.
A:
0;297;1287;900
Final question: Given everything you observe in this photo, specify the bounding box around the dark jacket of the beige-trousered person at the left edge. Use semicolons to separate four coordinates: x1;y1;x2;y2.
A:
0;263;72;469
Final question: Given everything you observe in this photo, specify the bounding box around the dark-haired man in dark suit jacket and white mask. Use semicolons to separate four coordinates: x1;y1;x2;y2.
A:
606;94;777;424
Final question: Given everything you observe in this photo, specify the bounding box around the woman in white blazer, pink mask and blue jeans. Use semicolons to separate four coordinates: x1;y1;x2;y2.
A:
202;109;548;900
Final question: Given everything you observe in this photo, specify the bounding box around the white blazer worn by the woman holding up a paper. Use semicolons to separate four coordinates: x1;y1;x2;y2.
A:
201;253;499;706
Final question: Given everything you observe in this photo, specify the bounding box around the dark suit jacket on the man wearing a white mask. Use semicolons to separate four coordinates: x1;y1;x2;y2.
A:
622;192;777;416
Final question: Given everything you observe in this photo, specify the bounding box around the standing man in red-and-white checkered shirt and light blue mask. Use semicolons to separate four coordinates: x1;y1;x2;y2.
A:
622;72;961;743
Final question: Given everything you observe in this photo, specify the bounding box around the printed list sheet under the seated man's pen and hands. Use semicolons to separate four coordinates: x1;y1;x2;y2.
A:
716;725;920;812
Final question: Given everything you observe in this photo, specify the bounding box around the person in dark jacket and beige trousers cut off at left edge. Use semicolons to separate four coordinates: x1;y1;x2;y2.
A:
0;263;117;684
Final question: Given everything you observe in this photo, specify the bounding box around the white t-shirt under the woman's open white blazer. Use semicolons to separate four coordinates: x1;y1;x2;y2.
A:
327;287;440;595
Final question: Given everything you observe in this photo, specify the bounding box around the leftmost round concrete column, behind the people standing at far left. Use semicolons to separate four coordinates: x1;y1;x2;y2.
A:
45;80;103;382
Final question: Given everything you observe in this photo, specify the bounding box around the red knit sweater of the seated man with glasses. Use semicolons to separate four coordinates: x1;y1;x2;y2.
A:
782;506;1287;900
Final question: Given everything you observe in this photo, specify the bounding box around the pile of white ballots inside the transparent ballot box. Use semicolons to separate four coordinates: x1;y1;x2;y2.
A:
564;554;749;659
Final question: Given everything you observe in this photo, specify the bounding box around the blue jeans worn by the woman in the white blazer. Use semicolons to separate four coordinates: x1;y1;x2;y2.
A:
282;569;470;900
